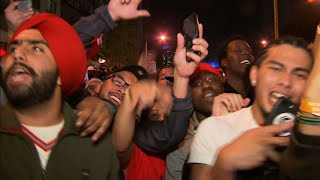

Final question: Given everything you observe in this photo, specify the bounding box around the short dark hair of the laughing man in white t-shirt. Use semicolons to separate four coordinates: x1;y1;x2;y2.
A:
254;36;314;67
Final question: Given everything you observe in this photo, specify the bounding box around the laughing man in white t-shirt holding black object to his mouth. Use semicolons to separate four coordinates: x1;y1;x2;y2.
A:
189;37;313;180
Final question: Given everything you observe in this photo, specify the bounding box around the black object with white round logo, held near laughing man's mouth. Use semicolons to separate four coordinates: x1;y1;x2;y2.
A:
265;97;299;136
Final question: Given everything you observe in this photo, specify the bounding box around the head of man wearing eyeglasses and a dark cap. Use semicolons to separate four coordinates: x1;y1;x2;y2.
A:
87;65;148;107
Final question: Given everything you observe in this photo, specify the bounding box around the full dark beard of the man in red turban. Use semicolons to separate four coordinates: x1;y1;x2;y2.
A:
2;65;58;109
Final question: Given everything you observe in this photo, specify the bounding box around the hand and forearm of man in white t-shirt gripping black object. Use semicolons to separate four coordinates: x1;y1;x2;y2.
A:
216;121;293;172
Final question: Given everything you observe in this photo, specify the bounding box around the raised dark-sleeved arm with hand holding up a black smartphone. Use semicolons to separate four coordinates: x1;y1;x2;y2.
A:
135;24;208;155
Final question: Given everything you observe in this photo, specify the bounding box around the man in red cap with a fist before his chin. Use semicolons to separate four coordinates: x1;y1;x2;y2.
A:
166;63;249;179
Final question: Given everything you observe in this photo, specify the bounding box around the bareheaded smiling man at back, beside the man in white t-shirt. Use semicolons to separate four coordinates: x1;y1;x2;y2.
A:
218;36;254;98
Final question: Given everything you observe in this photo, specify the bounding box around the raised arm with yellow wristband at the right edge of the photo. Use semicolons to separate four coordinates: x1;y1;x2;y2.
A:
280;25;320;180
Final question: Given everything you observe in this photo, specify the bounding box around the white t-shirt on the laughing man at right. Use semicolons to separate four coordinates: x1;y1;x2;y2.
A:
188;107;259;166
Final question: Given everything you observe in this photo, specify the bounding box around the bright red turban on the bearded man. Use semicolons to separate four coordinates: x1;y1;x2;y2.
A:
10;13;87;96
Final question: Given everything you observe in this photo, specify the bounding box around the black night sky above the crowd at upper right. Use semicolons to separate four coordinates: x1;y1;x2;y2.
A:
144;0;320;58
